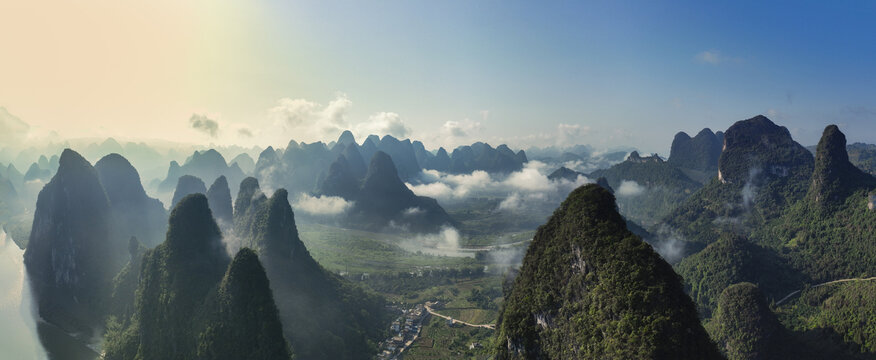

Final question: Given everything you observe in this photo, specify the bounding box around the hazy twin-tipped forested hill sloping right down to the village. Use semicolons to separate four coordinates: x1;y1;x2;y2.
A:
234;178;389;359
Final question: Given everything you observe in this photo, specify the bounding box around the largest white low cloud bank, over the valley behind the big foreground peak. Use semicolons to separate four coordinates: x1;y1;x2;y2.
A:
407;161;591;212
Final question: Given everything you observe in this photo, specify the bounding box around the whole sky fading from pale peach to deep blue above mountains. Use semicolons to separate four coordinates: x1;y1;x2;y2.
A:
0;0;876;154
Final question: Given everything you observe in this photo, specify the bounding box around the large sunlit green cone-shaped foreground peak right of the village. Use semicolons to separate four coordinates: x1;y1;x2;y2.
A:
494;184;720;359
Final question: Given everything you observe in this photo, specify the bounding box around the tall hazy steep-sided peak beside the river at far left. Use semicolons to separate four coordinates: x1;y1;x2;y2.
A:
24;149;127;334
